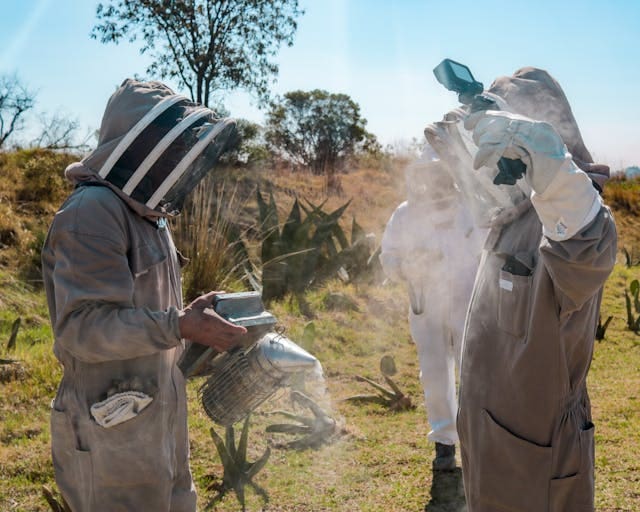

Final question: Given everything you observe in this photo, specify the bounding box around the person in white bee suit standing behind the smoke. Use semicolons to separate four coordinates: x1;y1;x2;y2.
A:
380;144;483;470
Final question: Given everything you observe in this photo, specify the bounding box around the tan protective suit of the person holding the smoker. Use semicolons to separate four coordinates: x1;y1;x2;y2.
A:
42;80;206;512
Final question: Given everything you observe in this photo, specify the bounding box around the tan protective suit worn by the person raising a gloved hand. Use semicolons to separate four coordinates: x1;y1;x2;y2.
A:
458;69;616;512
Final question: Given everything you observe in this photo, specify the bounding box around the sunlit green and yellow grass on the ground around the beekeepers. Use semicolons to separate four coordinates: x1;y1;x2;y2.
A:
0;150;640;512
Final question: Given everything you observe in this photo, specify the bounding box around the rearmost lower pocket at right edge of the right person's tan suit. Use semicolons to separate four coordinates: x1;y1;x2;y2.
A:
549;423;595;512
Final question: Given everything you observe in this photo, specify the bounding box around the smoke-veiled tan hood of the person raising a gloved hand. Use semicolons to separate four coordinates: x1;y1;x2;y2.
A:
488;67;609;186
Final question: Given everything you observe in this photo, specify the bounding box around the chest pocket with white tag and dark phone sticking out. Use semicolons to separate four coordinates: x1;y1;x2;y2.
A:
498;255;534;339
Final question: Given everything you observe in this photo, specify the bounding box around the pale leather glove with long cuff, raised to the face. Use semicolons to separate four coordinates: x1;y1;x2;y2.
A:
465;111;602;241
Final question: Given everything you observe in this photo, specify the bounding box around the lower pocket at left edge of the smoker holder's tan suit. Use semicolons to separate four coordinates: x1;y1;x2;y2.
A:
51;408;93;510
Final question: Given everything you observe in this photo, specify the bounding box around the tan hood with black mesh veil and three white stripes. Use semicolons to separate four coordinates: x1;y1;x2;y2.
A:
65;79;236;218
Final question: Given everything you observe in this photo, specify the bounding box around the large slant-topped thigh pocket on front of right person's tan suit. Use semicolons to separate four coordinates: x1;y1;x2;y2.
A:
478;410;552;512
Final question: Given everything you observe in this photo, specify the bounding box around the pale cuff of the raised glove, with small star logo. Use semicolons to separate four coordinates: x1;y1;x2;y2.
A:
531;160;602;242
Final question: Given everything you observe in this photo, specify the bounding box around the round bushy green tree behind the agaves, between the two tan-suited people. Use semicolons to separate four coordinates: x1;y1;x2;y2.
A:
265;89;377;182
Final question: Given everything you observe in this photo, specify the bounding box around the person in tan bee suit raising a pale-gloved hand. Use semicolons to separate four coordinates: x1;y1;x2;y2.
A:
434;68;616;512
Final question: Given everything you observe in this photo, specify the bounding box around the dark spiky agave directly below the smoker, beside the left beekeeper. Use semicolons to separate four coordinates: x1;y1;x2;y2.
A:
209;416;271;512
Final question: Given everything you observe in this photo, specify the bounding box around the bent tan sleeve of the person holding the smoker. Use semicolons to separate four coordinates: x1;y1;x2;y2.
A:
49;189;180;363
